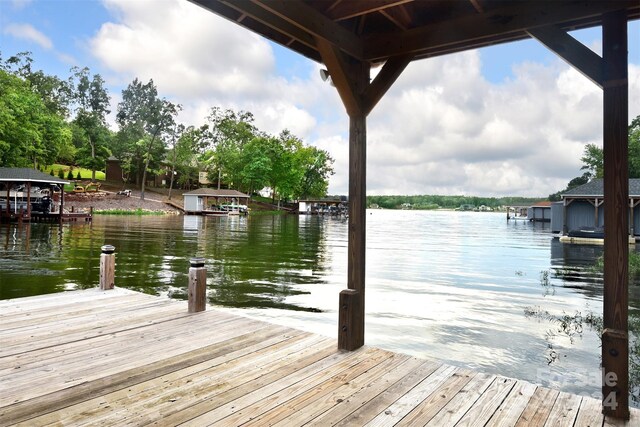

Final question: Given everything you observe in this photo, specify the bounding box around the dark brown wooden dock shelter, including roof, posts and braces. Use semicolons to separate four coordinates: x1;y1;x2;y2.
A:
191;0;640;419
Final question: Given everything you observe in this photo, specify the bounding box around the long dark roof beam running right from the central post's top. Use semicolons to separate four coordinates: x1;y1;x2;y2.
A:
363;0;640;62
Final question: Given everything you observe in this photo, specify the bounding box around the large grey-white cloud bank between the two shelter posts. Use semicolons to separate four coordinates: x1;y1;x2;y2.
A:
358;51;640;196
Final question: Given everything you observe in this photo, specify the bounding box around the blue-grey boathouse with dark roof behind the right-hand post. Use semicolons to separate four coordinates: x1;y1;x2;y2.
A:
551;178;640;237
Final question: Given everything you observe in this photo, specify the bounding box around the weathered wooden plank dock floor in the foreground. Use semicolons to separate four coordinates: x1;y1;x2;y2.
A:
0;289;640;427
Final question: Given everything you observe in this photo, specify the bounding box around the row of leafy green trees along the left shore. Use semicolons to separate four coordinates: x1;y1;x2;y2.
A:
0;52;334;199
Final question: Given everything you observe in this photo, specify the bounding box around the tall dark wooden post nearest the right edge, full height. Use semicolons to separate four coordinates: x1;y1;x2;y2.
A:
602;11;629;419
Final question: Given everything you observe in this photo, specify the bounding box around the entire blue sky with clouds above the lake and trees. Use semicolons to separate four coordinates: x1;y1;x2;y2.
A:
0;0;640;196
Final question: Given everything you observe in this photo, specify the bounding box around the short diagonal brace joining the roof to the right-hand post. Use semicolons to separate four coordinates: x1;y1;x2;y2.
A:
528;26;604;88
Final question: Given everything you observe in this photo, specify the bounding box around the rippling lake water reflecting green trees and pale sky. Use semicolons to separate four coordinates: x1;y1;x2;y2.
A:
0;210;640;397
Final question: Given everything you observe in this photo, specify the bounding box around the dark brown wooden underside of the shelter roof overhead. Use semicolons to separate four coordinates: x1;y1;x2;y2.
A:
190;0;640;65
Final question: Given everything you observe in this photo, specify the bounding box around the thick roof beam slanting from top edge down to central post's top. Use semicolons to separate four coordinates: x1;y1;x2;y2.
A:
250;0;363;59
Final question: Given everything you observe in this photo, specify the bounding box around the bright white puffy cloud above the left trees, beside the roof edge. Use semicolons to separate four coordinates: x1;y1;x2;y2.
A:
90;0;274;100
